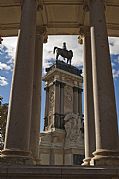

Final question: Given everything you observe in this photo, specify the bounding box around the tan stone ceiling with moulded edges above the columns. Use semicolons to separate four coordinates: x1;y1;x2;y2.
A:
0;0;119;36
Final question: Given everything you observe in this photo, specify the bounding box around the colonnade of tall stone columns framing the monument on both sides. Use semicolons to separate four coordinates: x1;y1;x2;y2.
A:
2;0;119;166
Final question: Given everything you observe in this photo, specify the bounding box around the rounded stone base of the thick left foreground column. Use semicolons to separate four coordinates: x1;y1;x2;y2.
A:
0;149;35;165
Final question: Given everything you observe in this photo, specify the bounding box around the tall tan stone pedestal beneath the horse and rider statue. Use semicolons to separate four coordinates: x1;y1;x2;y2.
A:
39;61;84;165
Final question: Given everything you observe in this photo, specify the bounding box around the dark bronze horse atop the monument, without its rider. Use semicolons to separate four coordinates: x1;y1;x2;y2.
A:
54;47;73;65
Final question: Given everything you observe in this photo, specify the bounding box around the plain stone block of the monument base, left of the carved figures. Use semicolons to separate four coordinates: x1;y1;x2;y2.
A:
38;129;65;165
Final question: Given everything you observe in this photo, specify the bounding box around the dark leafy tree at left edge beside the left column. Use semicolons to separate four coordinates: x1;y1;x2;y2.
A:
0;96;8;150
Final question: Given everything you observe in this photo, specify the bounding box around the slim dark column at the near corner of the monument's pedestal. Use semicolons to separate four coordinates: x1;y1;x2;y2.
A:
54;81;60;128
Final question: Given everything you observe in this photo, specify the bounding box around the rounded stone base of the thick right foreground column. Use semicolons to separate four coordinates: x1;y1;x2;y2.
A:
90;149;119;166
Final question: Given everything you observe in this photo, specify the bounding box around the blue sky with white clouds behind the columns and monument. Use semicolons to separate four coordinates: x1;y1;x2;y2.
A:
0;36;119;128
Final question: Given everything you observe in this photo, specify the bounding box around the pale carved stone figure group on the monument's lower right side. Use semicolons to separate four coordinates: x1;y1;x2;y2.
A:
64;113;83;147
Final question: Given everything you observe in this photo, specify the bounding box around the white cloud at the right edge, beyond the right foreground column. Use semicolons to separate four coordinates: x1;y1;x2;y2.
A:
109;37;119;55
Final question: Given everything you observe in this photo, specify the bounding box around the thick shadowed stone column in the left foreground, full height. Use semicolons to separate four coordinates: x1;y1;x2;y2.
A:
2;0;37;162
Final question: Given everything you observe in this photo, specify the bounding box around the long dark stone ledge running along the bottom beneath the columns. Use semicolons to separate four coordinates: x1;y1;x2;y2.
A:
0;166;119;179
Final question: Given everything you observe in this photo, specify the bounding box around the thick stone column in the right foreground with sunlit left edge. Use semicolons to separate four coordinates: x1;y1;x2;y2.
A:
89;0;119;166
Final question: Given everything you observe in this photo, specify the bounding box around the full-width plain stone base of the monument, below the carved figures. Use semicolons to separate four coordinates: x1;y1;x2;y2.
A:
39;128;84;165
